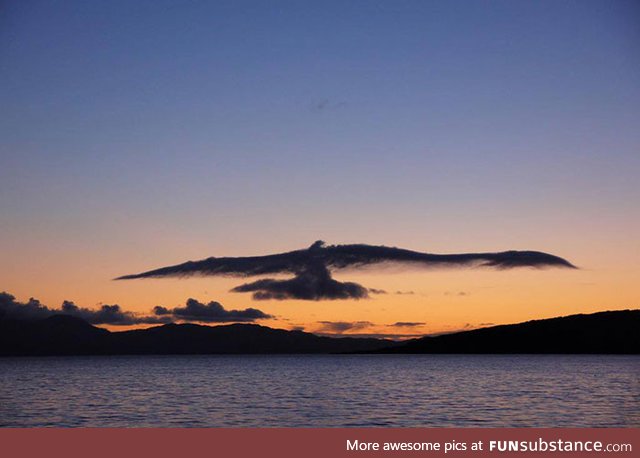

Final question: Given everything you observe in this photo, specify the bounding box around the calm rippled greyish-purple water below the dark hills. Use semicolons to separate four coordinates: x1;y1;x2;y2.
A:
0;355;640;427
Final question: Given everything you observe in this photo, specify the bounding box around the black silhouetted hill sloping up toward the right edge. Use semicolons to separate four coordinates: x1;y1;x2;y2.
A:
379;310;640;354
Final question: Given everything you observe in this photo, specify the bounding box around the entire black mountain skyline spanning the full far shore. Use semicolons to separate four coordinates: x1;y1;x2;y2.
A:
0;310;640;356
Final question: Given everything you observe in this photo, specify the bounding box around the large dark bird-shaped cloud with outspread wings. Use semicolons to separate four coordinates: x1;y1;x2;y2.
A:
116;241;575;300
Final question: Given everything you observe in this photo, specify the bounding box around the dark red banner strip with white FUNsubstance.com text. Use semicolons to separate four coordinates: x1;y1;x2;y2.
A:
0;428;640;458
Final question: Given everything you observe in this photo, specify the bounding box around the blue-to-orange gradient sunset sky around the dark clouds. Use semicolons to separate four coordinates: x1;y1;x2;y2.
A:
0;1;640;334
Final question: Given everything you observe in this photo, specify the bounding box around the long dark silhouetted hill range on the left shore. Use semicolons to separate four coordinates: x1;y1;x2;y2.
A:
0;315;395;356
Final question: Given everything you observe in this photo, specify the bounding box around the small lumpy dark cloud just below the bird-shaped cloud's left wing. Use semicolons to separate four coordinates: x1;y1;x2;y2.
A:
153;299;273;323
